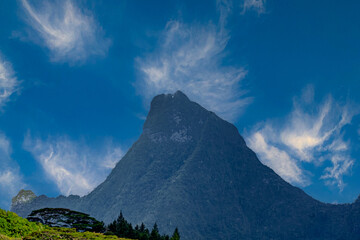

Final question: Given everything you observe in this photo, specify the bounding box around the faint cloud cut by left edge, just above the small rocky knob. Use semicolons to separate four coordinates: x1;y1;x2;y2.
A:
0;133;26;207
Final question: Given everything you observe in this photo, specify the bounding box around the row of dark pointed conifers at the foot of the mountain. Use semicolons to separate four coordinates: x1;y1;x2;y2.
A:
107;212;180;240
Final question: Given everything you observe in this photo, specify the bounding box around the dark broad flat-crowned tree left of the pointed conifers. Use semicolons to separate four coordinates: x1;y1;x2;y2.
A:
27;208;104;232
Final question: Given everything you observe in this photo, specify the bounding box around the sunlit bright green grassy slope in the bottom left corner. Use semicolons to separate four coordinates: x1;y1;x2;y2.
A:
0;209;131;240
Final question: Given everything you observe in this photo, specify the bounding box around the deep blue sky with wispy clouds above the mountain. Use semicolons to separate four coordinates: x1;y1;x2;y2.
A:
0;0;360;209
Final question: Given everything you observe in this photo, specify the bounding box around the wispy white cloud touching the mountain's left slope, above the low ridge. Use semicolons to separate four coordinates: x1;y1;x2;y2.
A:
24;134;123;196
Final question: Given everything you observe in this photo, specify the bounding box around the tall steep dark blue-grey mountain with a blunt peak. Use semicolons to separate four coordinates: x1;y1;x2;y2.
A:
12;91;360;239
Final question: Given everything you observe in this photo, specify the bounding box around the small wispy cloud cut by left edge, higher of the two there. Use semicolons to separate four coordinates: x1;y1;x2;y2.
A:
0;55;20;109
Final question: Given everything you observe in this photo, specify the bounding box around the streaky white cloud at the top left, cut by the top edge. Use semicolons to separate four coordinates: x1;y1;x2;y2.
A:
22;0;111;63
